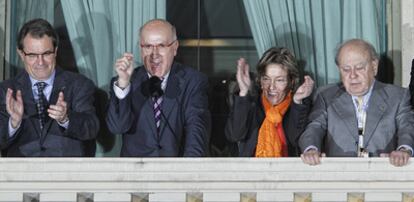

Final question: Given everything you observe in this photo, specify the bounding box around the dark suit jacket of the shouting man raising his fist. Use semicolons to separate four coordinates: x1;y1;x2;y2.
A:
106;63;211;157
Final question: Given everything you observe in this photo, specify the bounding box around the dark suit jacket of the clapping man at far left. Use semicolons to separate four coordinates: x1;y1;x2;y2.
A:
0;69;99;157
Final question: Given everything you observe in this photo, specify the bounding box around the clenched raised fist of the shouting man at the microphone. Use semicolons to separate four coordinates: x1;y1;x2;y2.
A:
115;53;134;88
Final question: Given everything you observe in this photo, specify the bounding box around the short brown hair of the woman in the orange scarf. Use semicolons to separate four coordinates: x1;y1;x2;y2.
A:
256;47;299;91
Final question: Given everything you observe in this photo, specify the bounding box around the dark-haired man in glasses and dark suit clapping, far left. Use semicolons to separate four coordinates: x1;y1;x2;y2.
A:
0;19;99;157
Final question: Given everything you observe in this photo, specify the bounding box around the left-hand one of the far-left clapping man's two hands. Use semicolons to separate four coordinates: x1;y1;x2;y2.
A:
6;88;24;128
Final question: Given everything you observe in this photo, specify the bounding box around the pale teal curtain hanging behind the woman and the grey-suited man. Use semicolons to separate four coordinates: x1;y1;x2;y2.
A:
244;0;386;86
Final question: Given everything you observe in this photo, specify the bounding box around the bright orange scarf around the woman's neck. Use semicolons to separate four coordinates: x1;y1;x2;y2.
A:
256;92;292;157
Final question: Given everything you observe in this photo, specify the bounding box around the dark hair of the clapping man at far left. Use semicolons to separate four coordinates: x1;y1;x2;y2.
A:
17;18;59;50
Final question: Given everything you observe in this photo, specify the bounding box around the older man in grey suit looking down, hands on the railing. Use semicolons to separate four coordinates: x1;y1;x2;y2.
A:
299;39;414;166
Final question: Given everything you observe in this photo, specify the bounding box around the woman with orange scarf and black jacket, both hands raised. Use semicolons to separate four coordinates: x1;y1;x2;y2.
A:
225;48;313;157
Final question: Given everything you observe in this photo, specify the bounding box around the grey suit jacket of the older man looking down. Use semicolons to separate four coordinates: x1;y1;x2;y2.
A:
299;81;414;157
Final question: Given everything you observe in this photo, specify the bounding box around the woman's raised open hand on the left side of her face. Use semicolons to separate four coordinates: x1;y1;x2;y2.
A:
236;58;251;96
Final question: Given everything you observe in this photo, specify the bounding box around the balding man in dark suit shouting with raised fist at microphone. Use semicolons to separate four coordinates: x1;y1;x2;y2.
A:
106;19;211;157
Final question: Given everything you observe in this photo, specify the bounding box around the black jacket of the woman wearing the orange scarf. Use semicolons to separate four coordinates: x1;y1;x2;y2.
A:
225;92;311;157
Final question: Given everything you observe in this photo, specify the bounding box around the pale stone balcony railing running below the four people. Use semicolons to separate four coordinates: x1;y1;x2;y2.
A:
0;158;414;202
